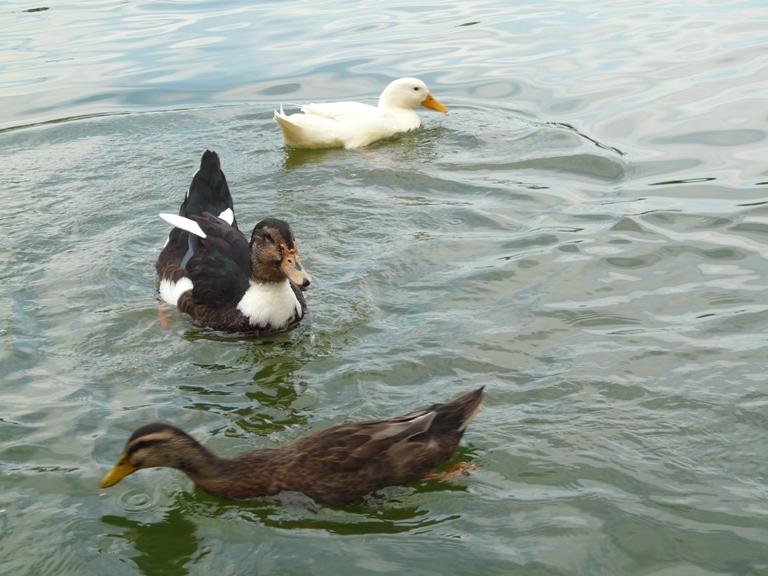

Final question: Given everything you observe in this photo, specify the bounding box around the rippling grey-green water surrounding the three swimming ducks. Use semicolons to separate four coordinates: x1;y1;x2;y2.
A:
0;0;768;576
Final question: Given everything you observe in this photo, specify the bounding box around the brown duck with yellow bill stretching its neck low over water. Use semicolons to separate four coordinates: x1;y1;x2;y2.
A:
101;388;483;505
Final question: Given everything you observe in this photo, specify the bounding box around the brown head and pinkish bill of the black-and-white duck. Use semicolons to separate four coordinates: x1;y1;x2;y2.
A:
251;218;312;290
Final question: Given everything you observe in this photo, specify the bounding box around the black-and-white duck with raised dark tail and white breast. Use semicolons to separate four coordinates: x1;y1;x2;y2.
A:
155;150;311;335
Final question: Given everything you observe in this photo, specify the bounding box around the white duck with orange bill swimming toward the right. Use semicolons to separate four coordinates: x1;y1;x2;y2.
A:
275;78;448;148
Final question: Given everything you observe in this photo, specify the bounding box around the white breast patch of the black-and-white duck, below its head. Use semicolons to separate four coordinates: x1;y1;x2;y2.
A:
237;280;301;328
